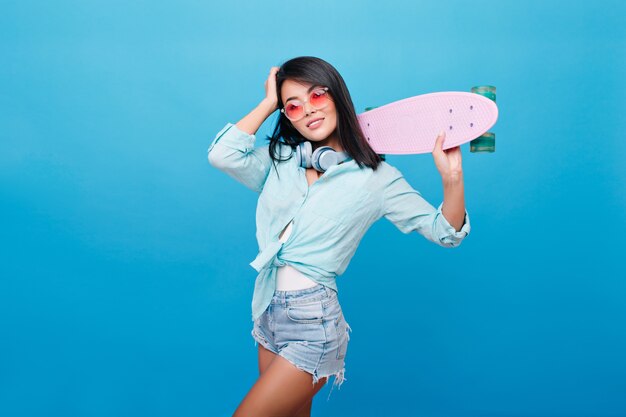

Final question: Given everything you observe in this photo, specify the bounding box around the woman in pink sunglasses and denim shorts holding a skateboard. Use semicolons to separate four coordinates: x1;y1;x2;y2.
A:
208;57;470;417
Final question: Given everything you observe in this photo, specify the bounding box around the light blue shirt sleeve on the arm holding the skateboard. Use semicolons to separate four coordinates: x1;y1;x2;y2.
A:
381;168;470;247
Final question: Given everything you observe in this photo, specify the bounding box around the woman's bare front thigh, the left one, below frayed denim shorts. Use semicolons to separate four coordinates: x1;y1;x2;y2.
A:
233;356;327;417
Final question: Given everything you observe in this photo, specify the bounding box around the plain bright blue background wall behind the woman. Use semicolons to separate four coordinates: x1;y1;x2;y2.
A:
0;0;626;417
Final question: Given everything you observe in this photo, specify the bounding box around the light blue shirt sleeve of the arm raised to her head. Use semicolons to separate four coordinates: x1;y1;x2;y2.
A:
207;123;272;192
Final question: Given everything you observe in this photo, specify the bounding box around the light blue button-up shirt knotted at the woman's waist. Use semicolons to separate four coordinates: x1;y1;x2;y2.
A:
208;123;470;320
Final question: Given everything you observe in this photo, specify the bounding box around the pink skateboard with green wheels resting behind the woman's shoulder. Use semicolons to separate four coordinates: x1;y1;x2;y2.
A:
357;86;498;154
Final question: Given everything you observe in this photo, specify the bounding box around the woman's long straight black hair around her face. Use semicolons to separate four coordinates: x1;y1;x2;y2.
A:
267;56;385;176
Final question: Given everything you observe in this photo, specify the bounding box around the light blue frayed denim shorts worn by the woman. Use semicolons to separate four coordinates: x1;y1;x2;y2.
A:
251;284;352;398
